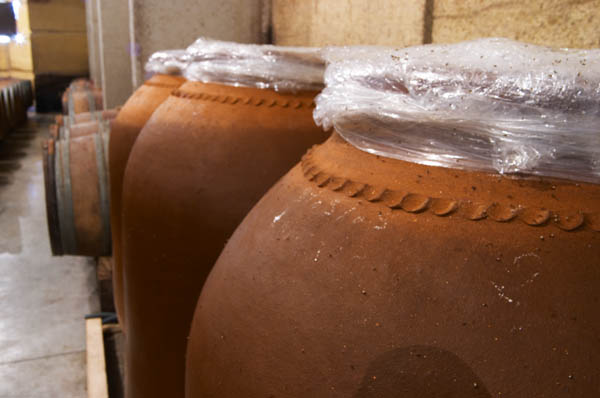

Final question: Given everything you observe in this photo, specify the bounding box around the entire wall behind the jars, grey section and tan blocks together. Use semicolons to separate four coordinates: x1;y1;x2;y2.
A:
85;0;600;107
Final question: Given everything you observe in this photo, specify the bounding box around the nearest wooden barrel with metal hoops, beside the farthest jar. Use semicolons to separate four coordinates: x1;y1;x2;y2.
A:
43;122;111;256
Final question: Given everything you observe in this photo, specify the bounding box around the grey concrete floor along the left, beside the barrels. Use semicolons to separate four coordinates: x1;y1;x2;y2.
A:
0;115;99;398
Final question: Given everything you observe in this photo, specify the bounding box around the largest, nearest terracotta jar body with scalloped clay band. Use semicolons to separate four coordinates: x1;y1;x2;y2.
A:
186;134;600;398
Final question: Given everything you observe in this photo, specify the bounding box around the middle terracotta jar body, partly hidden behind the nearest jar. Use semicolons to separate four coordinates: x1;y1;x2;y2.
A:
122;82;327;398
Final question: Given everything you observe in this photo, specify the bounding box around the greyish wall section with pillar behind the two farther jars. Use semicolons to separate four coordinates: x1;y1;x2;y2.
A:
87;0;270;107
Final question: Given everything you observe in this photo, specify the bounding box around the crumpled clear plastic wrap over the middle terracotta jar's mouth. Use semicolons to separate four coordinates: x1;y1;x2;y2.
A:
185;38;325;92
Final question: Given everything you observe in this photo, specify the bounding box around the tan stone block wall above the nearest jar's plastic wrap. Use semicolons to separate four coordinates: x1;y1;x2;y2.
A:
273;0;600;48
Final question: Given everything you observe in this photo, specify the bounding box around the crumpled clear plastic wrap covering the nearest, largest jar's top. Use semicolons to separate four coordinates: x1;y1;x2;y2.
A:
314;39;600;183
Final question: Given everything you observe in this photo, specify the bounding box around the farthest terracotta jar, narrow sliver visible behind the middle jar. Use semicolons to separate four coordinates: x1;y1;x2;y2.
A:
109;75;185;333
